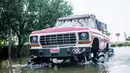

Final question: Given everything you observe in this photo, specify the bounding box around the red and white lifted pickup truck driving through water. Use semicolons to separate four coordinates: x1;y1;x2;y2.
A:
27;14;113;63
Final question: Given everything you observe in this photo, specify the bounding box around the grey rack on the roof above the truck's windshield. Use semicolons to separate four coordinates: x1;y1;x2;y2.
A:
58;14;96;21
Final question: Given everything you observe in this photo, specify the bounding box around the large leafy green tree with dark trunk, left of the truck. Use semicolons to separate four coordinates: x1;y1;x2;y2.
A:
0;0;73;56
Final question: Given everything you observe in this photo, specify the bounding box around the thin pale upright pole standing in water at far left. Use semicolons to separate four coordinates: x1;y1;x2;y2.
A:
8;29;12;67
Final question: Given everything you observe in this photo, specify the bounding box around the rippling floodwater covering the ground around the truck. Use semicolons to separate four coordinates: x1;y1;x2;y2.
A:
0;47;130;73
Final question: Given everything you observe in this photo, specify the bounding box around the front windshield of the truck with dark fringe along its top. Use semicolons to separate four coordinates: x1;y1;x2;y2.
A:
55;19;95;28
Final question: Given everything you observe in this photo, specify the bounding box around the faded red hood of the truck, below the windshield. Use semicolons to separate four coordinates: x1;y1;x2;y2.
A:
31;27;89;34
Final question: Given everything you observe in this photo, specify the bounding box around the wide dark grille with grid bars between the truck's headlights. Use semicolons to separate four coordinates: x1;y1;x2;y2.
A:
40;33;76;46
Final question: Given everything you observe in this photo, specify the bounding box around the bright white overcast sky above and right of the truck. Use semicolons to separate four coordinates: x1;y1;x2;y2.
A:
68;0;130;41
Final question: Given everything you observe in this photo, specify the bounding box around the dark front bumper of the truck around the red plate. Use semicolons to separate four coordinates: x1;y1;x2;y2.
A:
29;47;91;58
